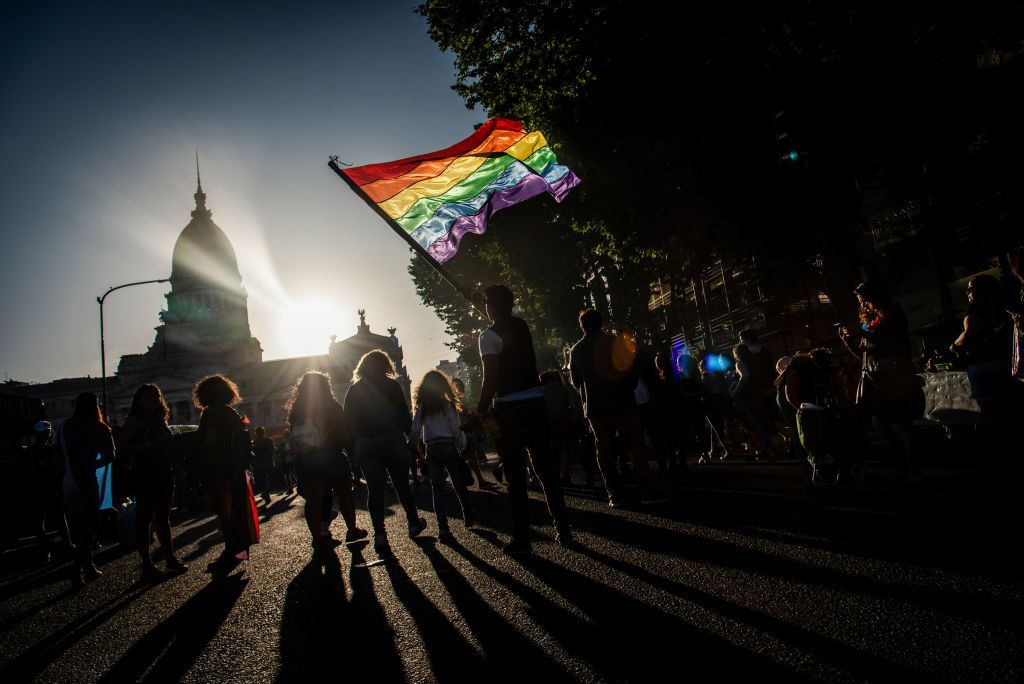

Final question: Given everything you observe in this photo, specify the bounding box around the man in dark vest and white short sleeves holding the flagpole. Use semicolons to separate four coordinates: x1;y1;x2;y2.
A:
476;285;572;554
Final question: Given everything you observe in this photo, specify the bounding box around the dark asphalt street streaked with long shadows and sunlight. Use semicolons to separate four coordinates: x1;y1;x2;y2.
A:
0;463;1024;682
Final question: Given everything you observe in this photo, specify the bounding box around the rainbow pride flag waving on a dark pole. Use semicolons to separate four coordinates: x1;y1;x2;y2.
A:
341;119;580;263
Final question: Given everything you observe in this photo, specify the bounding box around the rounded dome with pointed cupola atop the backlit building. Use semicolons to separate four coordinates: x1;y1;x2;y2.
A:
171;176;242;292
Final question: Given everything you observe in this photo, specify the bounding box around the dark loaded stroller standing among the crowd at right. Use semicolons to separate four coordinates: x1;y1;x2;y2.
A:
791;349;864;486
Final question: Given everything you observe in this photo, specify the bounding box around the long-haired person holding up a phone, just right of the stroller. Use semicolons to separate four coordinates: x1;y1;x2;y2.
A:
840;281;925;484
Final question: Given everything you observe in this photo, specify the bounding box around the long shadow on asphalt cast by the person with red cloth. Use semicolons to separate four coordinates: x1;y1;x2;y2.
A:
99;574;249;682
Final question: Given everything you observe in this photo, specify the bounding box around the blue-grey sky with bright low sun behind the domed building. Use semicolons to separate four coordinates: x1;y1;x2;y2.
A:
0;0;486;382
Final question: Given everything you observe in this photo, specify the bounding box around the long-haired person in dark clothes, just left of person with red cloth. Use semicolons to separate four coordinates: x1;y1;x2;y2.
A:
118;384;188;582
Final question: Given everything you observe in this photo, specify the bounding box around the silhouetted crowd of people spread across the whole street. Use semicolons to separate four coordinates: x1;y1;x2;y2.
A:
9;251;1024;585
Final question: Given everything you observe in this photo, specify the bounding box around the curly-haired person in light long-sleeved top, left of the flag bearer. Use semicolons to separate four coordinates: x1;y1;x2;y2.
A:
410;371;474;542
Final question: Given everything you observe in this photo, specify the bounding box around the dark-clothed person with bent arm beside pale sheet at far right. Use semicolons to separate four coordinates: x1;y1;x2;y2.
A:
949;275;1020;456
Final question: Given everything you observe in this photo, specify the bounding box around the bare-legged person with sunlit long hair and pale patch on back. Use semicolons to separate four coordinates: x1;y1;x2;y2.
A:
286;371;368;556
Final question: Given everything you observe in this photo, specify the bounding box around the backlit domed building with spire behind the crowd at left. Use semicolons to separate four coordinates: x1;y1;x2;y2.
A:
19;169;410;435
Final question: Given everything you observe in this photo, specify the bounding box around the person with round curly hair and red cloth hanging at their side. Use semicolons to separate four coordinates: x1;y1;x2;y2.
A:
193;375;259;572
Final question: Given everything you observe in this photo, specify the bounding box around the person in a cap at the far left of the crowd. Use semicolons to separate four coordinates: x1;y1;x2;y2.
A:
22;421;75;556
